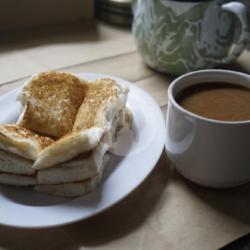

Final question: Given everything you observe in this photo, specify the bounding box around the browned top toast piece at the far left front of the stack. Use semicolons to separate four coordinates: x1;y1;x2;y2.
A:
0;124;54;160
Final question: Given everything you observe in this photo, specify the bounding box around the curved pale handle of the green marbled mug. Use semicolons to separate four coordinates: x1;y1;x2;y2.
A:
216;2;250;64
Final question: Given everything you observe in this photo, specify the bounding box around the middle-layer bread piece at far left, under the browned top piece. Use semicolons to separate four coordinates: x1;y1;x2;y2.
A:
0;150;35;175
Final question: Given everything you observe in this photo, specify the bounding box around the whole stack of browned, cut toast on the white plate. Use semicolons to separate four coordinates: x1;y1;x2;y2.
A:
0;72;131;197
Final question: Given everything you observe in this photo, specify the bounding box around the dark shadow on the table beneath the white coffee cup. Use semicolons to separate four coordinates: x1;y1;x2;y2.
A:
176;170;250;225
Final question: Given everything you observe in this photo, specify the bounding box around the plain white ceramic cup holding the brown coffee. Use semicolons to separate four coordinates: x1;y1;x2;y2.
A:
166;70;250;187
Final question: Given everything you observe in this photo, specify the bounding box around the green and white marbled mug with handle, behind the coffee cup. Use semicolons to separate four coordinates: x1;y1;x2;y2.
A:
133;0;250;75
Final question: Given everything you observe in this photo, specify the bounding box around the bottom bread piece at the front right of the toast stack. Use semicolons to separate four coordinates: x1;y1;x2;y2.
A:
34;175;100;197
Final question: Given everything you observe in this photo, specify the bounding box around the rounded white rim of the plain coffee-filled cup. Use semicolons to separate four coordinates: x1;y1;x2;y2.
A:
167;69;250;125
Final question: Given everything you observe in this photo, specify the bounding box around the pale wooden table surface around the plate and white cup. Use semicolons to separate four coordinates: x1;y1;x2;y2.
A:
0;22;250;250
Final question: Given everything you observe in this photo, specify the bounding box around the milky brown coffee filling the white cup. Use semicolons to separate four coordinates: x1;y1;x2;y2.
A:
176;82;250;121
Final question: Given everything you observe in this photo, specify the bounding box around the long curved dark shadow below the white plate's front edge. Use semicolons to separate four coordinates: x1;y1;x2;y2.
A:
0;154;171;250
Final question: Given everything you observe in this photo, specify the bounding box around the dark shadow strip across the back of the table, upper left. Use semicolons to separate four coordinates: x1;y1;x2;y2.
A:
0;21;101;52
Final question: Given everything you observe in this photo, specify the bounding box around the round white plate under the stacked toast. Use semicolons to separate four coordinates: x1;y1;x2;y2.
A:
0;74;165;228
